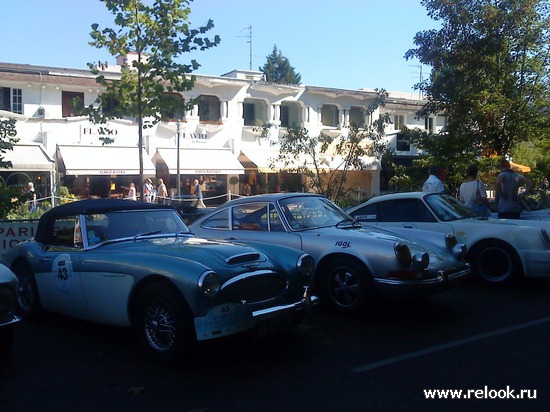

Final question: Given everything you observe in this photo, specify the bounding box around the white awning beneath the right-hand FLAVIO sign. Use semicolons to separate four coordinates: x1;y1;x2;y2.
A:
153;148;244;175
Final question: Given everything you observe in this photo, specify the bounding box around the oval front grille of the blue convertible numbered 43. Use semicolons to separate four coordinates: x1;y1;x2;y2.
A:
221;271;288;303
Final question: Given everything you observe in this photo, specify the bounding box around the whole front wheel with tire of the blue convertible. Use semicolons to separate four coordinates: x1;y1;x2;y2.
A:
135;283;195;362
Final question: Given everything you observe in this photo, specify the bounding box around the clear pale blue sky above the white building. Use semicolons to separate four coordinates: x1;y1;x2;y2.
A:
0;0;439;92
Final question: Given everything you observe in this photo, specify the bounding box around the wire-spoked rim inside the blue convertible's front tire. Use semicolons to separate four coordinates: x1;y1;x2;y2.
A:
143;298;176;352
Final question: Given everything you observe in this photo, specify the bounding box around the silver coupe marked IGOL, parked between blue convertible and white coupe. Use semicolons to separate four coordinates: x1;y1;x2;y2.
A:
190;193;469;313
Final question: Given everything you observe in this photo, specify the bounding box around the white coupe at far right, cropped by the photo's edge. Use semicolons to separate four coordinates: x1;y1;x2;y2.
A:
348;192;550;283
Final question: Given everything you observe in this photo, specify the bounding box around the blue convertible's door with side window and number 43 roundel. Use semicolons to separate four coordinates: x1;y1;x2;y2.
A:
33;216;86;317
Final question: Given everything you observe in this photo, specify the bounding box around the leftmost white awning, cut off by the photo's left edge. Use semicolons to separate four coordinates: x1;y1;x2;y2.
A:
2;143;54;172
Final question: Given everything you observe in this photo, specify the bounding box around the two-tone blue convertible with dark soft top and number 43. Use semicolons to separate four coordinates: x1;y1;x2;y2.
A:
3;199;316;361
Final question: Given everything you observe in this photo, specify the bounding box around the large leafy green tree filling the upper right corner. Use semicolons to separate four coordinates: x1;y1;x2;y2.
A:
405;0;550;167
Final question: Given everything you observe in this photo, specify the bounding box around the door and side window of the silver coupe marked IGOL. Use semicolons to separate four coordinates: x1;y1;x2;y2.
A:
203;202;302;249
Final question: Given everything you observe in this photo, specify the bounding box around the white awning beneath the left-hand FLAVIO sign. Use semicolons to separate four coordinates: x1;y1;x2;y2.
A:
56;145;156;176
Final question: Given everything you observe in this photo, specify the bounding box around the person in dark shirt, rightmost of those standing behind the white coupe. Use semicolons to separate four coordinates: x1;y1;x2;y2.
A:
495;159;533;219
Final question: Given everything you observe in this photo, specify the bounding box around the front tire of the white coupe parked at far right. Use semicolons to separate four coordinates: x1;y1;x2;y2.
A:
470;241;523;285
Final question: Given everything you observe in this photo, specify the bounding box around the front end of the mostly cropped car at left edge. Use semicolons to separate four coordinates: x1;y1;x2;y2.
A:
0;265;21;360
